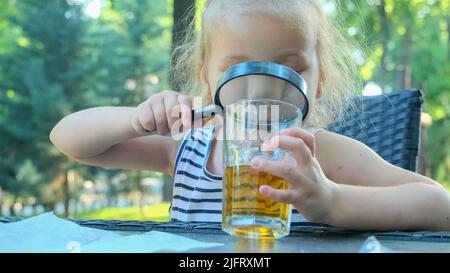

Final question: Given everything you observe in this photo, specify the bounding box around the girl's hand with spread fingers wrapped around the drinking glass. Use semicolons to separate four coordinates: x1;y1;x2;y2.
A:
251;128;336;224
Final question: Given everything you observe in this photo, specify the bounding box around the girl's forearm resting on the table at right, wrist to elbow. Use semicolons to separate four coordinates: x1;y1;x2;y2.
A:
329;182;450;230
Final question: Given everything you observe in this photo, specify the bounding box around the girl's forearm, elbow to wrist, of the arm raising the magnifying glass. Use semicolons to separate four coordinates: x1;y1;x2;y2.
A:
50;107;141;159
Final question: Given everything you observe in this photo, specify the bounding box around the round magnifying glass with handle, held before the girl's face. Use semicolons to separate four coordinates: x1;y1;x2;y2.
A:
192;62;309;120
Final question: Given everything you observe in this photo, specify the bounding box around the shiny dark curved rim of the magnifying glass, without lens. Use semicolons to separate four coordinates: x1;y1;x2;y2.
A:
214;62;309;120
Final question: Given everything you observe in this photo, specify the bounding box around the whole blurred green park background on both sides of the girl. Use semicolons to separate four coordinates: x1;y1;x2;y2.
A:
0;0;450;221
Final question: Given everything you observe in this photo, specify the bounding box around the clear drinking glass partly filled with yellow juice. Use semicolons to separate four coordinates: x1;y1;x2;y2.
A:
222;99;302;239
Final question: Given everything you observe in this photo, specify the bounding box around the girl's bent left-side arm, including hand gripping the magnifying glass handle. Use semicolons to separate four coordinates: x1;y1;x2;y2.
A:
50;91;190;174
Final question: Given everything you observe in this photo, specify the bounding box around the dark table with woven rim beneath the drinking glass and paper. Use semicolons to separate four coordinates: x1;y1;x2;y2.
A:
0;217;450;253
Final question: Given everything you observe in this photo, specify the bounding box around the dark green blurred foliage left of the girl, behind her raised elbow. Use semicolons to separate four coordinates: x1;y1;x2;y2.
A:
0;0;171;214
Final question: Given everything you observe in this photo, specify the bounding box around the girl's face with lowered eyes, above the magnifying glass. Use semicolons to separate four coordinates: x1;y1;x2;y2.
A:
202;12;320;110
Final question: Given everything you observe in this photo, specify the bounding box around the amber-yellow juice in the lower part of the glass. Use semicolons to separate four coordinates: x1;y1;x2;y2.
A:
222;165;291;239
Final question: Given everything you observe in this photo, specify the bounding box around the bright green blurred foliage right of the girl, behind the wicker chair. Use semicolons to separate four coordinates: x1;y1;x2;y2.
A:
337;0;450;185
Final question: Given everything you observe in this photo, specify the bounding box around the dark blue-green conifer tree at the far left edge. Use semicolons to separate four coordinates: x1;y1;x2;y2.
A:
1;1;88;215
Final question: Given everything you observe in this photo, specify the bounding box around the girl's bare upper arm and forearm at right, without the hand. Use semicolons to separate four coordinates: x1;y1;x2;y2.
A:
316;132;450;230
